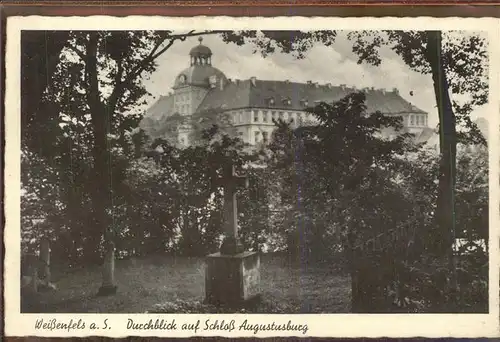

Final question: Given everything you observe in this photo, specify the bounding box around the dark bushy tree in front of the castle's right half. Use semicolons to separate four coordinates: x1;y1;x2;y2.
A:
268;93;416;312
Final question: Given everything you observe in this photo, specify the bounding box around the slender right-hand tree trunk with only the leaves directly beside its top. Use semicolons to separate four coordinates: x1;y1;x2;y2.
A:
351;31;488;255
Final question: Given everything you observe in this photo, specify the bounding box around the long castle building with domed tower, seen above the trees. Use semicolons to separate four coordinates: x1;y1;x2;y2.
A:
140;37;429;146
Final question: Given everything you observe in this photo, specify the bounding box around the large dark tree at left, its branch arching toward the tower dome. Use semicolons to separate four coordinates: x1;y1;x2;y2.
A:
22;31;225;292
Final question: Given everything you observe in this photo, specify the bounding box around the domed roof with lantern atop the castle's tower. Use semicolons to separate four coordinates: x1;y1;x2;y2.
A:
174;37;227;89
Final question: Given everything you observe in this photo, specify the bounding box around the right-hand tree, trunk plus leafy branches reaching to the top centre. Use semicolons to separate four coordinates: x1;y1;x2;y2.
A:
224;31;488;276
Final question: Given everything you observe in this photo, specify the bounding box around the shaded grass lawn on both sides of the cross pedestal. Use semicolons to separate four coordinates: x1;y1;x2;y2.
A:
22;255;351;313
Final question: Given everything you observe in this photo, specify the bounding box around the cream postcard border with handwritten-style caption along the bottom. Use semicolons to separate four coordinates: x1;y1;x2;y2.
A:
4;16;500;337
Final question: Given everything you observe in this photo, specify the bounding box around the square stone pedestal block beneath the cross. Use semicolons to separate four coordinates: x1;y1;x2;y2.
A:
205;252;260;307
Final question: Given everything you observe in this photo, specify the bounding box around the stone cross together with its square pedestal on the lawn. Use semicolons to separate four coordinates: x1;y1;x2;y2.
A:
205;164;260;307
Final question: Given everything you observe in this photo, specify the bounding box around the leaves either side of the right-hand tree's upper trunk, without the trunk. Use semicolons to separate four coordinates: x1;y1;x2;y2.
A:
349;31;488;144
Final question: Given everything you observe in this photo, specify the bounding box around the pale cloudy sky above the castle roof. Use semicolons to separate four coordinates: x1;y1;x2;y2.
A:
145;34;486;127
